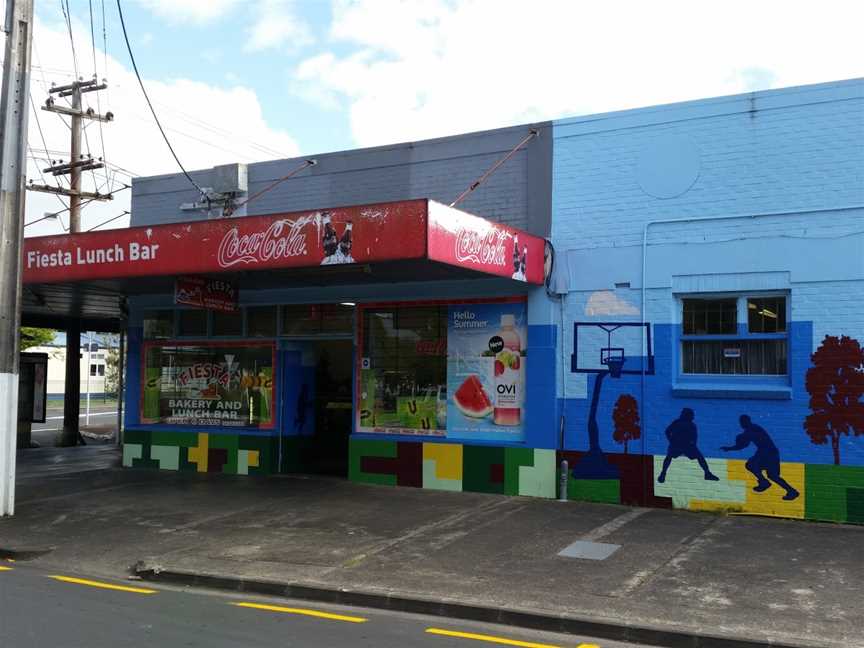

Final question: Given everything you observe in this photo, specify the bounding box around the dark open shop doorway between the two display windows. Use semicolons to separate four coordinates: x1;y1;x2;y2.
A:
303;340;354;477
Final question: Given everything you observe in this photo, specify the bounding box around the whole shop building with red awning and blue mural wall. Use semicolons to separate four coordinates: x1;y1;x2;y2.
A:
25;80;864;522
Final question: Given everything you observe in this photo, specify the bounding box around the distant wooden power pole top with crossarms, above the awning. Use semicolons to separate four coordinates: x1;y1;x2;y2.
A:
27;79;114;232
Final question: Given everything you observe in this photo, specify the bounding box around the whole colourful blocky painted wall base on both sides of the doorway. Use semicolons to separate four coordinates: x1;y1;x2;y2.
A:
123;430;864;524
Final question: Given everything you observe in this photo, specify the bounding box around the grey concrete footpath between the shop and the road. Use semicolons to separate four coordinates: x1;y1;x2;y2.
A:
0;447;864;648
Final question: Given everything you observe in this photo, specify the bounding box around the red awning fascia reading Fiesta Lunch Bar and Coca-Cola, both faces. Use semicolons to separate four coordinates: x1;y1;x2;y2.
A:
23;199;544;284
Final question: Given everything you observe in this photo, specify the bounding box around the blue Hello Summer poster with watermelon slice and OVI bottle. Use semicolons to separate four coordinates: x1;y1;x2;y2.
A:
447;302;528;441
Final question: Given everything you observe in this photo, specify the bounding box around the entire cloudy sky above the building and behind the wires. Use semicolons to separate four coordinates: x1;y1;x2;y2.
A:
11;0;864;236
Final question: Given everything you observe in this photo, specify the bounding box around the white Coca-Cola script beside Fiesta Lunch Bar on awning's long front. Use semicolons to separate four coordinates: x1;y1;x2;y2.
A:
218;216;314;268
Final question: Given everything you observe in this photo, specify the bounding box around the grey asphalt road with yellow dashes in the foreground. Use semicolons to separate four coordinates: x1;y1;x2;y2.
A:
0;562;635;648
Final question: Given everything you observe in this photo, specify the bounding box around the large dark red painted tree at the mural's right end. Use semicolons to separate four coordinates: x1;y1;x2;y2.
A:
804;335;864;465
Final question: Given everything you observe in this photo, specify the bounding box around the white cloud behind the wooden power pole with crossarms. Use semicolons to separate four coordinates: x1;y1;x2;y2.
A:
25;16;299;236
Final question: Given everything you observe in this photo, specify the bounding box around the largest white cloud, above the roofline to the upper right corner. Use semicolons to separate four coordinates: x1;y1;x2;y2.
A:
295;0;864;146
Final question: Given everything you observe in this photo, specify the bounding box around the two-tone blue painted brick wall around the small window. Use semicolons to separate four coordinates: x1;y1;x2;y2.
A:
552;79;864;465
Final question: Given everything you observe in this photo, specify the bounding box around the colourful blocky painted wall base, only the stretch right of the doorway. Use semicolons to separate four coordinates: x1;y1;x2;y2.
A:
350;440;864;524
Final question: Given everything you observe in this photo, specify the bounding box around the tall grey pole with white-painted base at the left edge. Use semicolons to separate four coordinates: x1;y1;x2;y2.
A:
0;0;33;515
